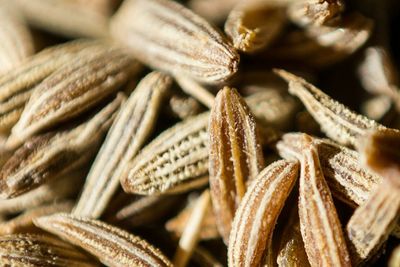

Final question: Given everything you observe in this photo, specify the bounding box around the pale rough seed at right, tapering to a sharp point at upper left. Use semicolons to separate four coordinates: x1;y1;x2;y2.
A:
276;70;385;145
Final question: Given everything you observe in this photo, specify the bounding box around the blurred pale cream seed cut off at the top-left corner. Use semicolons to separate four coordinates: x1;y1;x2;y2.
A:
0;0;34;75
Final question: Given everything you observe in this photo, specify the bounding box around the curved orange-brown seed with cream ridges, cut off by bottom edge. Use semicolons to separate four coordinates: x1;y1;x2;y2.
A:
228;160;299;266
